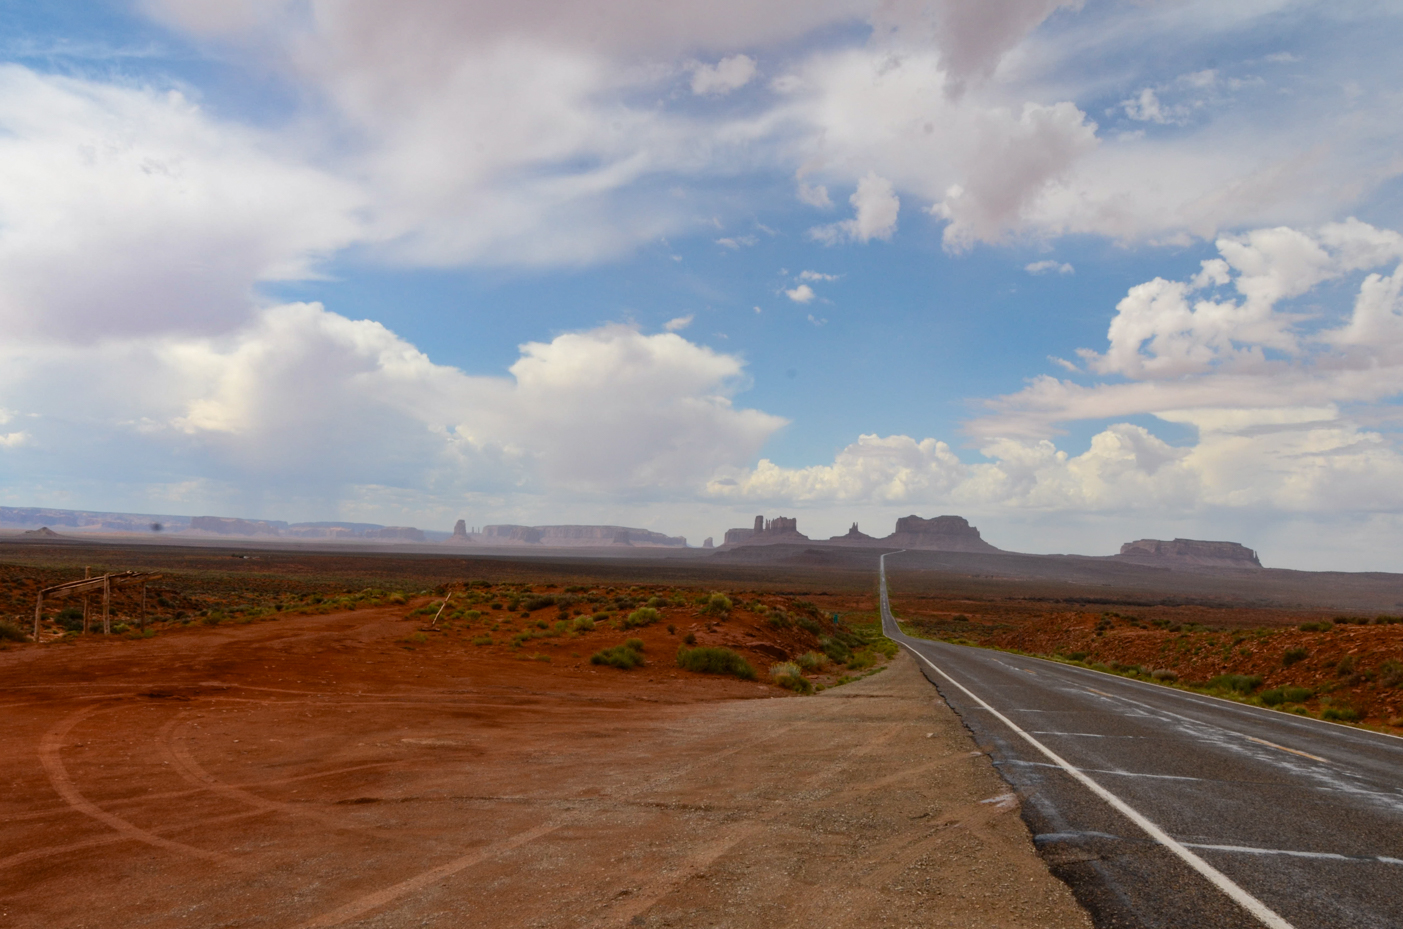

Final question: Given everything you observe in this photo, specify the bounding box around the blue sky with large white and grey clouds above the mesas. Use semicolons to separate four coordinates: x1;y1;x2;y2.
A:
0;0;1403;571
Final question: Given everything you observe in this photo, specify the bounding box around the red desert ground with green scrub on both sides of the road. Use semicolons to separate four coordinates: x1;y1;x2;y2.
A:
0;543;1403;929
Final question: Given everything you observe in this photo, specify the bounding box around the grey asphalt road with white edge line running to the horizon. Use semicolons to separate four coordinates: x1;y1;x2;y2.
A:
881;554;1403;929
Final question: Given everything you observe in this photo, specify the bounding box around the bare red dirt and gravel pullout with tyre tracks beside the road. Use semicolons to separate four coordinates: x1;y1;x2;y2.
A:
0;610;1090;929
